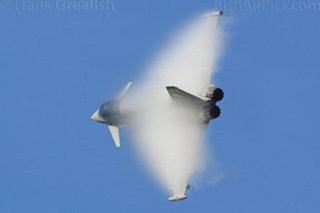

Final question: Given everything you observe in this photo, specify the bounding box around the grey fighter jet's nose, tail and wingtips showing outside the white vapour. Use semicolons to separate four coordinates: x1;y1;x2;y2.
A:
91;11;224;201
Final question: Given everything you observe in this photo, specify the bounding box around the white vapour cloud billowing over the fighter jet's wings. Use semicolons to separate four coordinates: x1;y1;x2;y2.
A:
124;13;221;196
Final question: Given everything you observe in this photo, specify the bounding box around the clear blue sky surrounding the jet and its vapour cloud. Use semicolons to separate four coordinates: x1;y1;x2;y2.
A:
0;0;320;213
